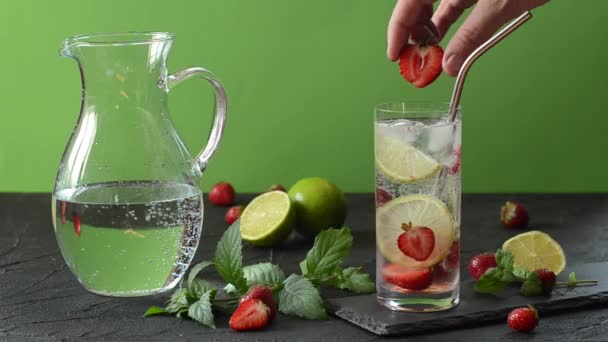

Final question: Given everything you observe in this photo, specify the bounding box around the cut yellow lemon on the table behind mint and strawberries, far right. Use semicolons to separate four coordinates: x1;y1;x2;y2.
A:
502;230;566;274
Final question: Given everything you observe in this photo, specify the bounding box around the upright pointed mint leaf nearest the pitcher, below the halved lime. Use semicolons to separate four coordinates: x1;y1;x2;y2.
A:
215;220;247;293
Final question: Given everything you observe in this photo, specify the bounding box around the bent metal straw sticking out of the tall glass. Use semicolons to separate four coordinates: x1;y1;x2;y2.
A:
449;11;532;122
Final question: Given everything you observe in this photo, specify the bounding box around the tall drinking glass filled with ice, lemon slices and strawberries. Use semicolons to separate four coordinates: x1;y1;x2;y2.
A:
374;102;462;311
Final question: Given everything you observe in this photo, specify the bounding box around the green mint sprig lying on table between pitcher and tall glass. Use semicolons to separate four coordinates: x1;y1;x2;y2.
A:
144;221;375;328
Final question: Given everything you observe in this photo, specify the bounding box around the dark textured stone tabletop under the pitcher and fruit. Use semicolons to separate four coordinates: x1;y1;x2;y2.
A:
0;194;608;342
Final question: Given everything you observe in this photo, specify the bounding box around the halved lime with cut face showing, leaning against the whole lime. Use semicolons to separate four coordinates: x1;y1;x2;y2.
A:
240;191;296;247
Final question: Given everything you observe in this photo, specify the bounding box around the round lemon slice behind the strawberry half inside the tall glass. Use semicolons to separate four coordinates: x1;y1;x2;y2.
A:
376;195;454;268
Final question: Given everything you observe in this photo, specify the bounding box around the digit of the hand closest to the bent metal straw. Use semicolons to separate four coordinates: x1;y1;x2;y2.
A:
443;0;548;76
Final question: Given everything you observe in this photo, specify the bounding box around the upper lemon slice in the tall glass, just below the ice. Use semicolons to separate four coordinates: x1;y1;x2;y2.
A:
376;138;441;183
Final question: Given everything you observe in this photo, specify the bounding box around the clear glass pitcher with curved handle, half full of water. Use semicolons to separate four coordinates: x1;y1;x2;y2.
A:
52;32;226;296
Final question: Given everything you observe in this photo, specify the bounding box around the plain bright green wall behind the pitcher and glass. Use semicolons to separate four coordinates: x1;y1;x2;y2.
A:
0;0;608;192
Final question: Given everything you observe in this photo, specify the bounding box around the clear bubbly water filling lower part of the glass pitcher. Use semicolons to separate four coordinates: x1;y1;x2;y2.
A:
53;182;203;296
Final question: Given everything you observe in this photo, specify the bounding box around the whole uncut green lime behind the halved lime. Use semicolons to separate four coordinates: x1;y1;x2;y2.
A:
289;177;346;237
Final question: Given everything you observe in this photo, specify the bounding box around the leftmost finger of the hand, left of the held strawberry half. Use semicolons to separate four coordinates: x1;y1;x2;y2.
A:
386;0;434;61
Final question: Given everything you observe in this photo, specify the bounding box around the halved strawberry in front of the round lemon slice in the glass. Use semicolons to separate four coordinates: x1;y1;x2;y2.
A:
397;223;435;261
